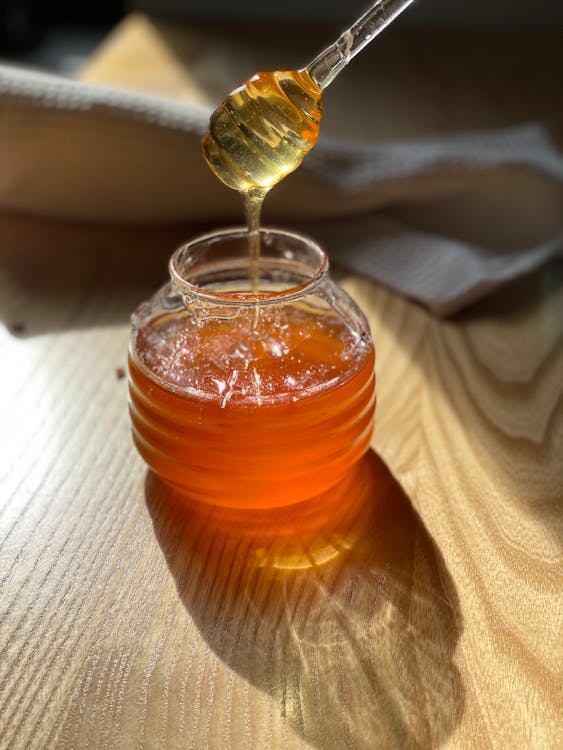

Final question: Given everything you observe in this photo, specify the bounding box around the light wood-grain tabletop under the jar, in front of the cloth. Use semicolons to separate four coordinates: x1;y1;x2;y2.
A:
0;16;563;750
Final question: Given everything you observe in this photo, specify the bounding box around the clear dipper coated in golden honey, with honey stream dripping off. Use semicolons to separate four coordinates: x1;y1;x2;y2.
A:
202;0;413;290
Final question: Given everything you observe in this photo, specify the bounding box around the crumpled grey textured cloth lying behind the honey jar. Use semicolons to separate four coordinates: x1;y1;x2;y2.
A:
0;61;563;315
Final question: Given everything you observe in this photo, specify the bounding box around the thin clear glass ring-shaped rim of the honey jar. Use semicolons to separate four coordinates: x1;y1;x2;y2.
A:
168;226;329;306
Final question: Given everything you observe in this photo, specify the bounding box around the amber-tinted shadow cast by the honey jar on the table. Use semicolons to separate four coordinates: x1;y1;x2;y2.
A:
146;452;464;750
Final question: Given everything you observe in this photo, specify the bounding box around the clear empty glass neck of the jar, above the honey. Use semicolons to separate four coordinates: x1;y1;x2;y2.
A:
169;227;328;307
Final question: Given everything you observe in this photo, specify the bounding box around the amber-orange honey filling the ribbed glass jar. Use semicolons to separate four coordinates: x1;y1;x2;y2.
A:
129;301;375;508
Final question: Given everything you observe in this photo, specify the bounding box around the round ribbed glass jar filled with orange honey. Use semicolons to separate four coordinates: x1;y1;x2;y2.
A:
129;228;375;508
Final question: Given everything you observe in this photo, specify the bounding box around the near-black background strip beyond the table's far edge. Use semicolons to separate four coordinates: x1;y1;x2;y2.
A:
0;0;563;74
